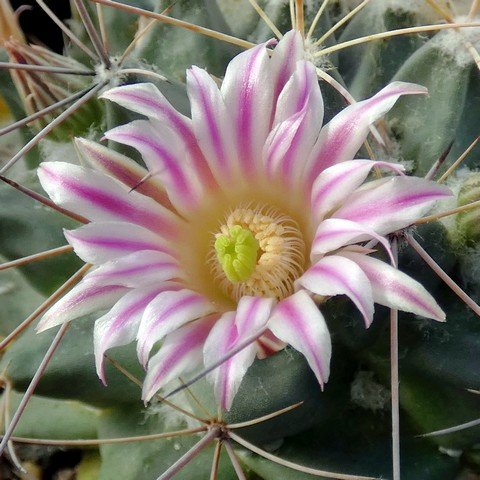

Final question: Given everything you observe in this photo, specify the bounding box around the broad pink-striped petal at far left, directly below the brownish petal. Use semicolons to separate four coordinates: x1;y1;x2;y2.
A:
38;162;180;237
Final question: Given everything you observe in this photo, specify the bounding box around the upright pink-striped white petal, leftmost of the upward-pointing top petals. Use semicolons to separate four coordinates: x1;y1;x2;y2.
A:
187;66;238;185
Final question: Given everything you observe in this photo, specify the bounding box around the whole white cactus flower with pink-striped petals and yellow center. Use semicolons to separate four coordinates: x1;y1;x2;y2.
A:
39;31;450;409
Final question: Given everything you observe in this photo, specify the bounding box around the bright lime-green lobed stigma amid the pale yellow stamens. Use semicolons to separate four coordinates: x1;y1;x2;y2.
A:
215;225;259;283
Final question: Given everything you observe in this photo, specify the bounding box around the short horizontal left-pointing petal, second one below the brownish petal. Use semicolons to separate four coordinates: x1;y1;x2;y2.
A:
63;222;173;265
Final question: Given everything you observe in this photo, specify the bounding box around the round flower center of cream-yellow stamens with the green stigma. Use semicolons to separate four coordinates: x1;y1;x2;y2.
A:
208;205;305;301
